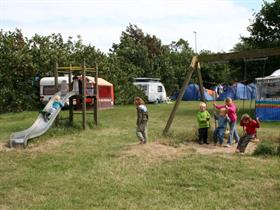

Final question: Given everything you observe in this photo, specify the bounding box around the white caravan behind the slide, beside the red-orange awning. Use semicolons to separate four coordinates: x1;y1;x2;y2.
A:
40;76;69;104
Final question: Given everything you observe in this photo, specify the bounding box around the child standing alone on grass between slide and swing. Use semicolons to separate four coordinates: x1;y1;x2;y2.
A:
134;97;149;144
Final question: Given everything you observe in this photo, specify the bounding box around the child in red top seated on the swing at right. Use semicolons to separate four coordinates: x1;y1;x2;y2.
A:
236;114;260;153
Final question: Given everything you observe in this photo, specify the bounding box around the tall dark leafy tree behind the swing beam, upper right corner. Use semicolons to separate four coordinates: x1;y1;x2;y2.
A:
232;0;280;82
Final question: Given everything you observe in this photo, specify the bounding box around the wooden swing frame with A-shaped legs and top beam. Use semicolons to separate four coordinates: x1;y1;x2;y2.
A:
163;48;280;135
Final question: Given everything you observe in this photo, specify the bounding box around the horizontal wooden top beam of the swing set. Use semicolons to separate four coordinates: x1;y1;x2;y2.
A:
198;48;280;62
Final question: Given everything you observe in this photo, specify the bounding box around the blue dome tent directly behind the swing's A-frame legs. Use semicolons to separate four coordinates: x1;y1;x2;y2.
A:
170;84;213;101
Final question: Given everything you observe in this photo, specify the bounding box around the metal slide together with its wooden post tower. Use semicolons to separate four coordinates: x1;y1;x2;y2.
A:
10;62;98;148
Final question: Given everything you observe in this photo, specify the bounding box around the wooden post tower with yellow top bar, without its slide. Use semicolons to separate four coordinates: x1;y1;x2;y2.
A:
54;62;98;130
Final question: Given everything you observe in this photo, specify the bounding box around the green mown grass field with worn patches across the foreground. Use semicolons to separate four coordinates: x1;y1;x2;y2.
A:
0;102;280;210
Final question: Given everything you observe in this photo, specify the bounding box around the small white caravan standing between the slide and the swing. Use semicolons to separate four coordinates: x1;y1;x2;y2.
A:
133;78;166;103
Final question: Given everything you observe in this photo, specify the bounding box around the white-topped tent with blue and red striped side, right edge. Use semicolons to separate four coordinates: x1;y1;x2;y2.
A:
256;69;280;121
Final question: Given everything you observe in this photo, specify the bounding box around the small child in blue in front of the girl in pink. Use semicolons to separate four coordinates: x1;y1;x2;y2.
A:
213;108;230;146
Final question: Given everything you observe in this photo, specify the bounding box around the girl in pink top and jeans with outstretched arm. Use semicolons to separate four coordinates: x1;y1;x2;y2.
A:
213;97;239;147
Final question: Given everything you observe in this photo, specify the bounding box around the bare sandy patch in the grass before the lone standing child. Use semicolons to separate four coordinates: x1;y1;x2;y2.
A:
122;142;186;162
